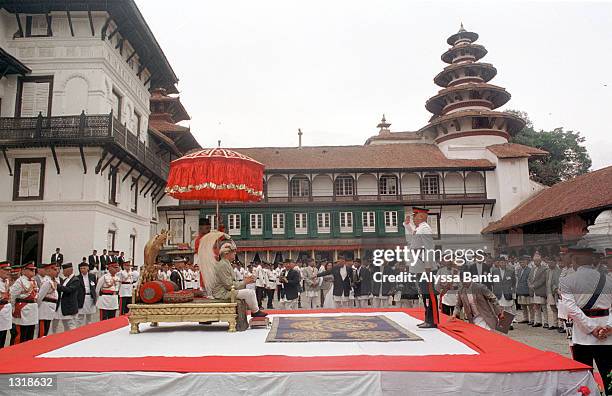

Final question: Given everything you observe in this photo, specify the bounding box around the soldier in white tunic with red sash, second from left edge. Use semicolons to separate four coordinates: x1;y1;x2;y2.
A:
10;262;38;345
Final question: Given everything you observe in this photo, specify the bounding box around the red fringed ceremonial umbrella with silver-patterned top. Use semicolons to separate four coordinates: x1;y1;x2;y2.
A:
166;148;264;202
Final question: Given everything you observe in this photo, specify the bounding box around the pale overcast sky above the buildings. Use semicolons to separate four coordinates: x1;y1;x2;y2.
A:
136;0;612;170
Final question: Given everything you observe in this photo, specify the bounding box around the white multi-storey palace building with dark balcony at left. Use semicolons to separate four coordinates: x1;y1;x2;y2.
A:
0;0;199;264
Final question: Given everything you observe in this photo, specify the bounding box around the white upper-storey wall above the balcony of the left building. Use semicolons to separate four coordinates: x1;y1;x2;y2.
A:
0;12;150;139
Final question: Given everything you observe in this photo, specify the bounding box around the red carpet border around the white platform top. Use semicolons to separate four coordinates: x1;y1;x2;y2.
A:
0;308;590;374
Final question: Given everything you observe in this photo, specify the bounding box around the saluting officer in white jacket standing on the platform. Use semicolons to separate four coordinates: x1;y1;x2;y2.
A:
409;208;440;329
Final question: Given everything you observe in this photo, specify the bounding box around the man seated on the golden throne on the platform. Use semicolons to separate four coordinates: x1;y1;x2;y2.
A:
211;240;267;318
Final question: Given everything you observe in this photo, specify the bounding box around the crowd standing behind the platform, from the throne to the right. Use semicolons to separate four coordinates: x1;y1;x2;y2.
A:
220;251;612;333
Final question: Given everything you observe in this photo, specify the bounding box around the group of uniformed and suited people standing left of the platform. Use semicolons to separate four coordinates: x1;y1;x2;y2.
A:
0;248;139;348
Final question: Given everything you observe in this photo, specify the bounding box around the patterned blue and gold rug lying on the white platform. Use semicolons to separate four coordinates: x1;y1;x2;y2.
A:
266;315;423;342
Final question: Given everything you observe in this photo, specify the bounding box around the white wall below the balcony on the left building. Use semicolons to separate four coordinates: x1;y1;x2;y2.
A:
0;148;158;264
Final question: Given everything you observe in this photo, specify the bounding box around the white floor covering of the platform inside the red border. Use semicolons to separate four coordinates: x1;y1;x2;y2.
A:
41;312;477;358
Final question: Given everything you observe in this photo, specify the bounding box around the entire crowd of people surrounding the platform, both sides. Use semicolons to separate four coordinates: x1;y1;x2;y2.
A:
0;229;612;390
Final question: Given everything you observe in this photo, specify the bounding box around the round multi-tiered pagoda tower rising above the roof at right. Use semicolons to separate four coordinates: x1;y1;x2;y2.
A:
419;24;525;157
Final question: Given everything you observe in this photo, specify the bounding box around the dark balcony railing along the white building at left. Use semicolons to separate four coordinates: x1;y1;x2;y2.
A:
0;113;169;179
